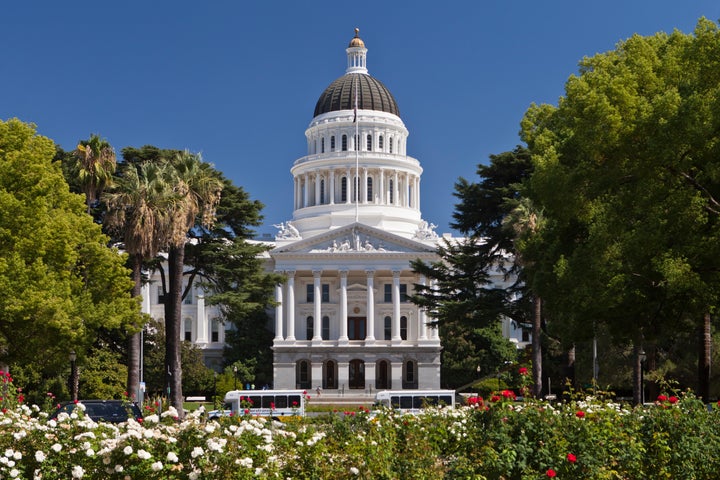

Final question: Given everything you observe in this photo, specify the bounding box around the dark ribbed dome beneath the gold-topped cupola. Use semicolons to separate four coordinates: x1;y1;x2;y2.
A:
313;73;400;117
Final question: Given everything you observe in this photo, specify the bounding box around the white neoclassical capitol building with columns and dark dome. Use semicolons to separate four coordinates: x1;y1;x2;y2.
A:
145;29;526;393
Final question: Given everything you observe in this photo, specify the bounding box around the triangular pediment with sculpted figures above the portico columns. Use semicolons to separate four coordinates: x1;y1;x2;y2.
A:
270;223;435;256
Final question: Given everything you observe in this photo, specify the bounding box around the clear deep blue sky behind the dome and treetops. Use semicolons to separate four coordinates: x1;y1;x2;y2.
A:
0;0;720;234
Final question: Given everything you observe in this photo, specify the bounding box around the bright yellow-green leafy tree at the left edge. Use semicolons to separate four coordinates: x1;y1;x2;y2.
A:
0;119;140;377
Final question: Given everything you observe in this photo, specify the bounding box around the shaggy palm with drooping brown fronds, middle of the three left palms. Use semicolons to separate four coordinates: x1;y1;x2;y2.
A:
104;162;176;402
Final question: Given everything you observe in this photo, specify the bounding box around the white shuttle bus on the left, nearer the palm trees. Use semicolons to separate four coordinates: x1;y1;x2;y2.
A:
211;390;307;419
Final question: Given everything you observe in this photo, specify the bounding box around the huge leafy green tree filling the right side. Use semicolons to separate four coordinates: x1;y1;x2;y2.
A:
523;19;720;401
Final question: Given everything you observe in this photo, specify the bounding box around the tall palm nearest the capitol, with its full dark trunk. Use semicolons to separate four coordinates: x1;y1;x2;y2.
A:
165;151;223;417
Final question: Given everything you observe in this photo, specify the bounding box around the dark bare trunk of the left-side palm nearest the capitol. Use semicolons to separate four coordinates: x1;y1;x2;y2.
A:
165;245;185;419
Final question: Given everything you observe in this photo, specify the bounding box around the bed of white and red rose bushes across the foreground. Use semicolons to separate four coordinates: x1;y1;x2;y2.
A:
0;386;720;479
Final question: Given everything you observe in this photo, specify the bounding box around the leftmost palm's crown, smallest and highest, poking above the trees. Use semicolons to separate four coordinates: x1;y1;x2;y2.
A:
73;133;117;214
